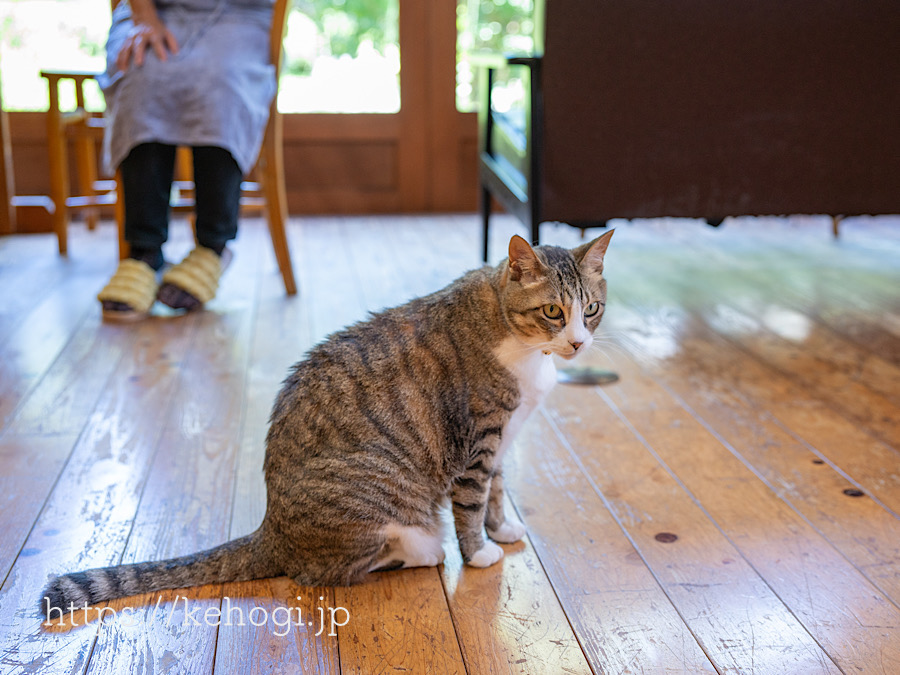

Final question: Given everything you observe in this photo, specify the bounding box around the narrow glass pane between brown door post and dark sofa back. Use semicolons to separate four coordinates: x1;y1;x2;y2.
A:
456;0;542;112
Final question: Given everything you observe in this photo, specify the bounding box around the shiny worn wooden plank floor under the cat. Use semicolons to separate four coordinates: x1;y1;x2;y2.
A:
0;215;900;675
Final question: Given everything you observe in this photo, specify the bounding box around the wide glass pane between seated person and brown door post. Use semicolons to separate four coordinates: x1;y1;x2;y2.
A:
278;0;400;113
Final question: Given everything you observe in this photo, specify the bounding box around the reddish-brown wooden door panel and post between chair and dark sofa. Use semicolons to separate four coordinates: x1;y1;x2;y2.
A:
283;0;477;213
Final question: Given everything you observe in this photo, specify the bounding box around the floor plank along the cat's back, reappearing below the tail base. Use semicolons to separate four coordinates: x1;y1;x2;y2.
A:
216;224;343;673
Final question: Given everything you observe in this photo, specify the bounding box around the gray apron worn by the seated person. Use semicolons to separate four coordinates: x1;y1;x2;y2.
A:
99;0;277;173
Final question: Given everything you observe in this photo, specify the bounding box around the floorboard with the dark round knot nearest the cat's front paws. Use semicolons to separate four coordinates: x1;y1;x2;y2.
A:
547;387;839;673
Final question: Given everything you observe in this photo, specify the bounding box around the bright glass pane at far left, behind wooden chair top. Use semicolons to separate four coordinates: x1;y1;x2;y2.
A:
0;0;110;110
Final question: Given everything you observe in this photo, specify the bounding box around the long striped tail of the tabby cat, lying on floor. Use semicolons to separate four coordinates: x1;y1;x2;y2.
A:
41;531;284;618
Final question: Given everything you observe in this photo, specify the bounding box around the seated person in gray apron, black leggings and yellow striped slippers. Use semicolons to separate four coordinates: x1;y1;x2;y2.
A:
98;0;277;320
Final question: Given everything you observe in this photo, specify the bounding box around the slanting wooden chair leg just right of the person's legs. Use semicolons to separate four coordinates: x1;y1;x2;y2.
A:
260;113;297;295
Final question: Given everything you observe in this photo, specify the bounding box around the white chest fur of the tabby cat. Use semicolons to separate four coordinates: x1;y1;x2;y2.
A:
494;338;556;467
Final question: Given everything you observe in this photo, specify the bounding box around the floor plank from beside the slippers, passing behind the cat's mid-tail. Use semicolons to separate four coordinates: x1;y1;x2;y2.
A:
87;226;260;673
